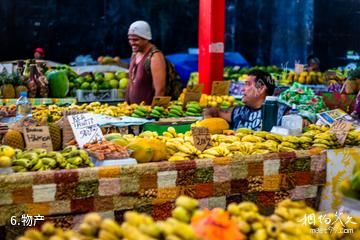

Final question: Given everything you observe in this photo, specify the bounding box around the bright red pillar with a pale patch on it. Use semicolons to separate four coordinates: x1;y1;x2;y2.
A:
198;0;225;94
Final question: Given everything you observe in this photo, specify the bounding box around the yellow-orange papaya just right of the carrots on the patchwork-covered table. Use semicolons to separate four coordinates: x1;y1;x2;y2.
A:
127;139;154;163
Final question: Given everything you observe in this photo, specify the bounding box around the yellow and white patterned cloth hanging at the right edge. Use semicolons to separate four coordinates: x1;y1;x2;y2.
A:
320;147;360;211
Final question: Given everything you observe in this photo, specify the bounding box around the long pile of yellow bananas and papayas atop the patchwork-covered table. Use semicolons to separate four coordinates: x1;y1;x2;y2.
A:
103;122;360;163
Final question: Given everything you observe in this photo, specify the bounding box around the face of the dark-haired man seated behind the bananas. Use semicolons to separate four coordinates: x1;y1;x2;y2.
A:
242;75;266;105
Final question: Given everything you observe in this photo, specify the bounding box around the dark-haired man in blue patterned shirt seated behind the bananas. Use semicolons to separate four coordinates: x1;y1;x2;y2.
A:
204;70;287;131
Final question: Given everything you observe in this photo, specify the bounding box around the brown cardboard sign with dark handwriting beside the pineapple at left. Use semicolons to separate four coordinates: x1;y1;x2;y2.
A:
24;126;53;151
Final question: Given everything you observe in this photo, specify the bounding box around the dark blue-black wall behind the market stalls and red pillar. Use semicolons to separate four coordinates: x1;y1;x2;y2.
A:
0;0;360;68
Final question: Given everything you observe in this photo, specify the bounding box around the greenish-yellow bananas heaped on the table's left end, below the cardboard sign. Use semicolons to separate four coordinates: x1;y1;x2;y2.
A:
12;146;93;172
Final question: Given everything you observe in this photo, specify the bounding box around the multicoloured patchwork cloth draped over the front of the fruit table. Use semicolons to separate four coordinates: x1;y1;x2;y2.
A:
0;151;326;239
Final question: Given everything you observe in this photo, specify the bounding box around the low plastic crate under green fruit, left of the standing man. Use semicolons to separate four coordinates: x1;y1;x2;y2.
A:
76;89;125;102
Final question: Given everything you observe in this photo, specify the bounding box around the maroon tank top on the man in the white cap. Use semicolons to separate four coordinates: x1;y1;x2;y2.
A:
126;48;155;105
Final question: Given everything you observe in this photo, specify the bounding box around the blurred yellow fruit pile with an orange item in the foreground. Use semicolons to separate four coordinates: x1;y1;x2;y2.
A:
18;196;360;240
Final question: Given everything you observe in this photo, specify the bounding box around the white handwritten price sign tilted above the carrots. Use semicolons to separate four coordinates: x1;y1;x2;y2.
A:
68;113;104;148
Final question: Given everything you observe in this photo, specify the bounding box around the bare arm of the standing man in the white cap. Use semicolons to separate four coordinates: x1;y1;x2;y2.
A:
150;52;166;96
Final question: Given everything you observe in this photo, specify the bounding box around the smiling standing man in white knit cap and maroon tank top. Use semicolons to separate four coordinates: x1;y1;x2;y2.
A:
126;21;166;104
